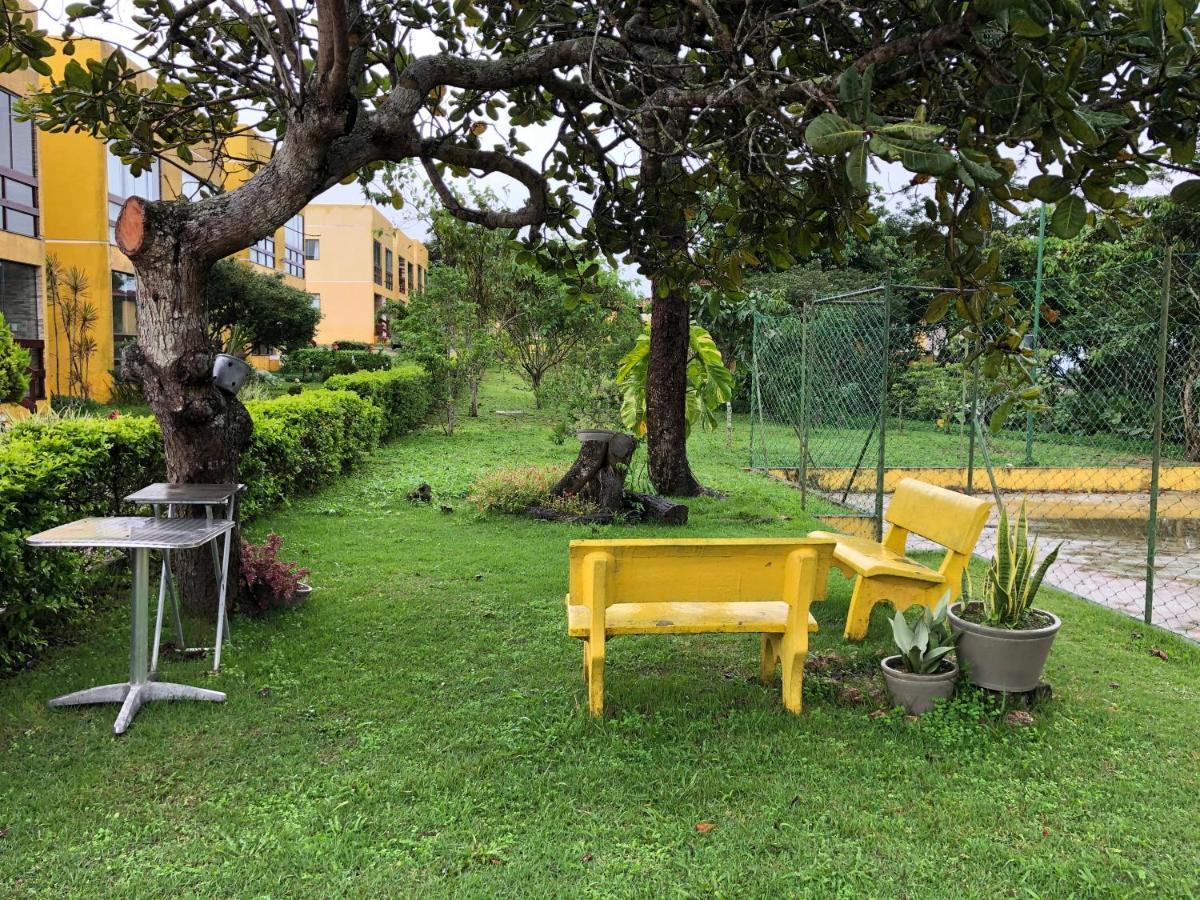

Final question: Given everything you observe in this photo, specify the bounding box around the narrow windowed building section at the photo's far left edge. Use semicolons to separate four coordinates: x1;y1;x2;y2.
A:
0;8;47;415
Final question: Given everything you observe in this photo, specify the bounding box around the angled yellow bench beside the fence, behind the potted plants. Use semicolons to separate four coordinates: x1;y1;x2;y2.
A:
809;479;992;641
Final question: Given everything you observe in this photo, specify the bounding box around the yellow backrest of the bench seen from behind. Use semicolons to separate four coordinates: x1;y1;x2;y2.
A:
570;538;836;606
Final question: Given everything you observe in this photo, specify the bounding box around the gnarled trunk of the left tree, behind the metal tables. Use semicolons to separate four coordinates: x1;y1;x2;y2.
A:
122;201;252;612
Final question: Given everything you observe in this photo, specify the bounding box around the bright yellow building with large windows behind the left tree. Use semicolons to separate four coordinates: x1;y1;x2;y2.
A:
37;38;305;401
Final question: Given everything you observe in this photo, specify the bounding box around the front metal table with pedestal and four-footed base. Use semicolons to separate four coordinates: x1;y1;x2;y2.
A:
26;516;234;734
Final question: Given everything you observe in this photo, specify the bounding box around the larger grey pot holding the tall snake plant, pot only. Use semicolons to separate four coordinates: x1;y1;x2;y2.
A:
949;602;1062;694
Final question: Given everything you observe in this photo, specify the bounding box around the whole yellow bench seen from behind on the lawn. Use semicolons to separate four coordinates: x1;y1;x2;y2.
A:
566;538;835;715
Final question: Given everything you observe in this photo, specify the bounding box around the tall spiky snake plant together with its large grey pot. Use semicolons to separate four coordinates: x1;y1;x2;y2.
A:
950;503;1062;694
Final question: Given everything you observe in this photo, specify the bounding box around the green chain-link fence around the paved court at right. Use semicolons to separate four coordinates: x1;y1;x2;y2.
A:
750;253;1200;638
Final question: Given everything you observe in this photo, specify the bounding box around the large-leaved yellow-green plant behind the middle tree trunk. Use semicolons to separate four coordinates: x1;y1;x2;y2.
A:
616;324;733;437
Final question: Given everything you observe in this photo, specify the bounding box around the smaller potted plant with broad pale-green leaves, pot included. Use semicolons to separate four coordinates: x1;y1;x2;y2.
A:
880;598;959;715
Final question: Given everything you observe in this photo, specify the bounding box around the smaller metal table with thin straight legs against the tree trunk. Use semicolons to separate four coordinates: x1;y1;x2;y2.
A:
125;481;246;672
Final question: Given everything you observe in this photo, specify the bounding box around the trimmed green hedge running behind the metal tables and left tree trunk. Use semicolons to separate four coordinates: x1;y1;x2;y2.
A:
0;366;428;671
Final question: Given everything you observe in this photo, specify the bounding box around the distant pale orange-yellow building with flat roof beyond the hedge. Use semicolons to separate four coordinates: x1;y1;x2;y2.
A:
305;203;430;343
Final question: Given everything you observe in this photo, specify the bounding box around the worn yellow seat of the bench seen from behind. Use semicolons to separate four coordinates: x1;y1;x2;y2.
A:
566;598;817;637
